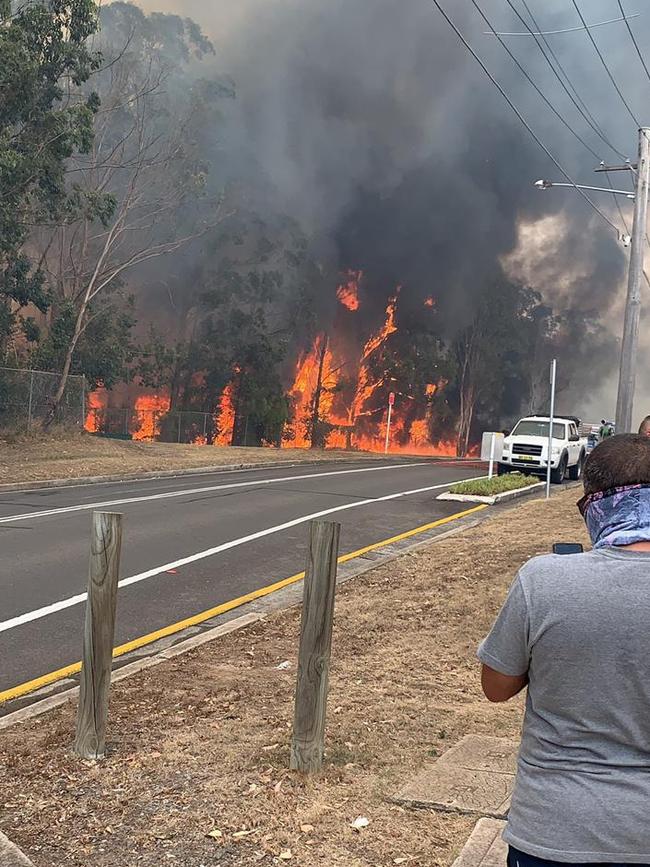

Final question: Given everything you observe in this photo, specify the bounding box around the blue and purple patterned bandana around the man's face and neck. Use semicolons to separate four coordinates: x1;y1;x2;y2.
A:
578;485;650;548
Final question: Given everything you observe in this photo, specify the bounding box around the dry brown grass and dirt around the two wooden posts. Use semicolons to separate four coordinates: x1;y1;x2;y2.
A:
0;490;586;867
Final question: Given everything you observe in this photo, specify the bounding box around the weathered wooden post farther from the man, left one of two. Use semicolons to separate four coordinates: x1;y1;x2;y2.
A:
74;512;122;759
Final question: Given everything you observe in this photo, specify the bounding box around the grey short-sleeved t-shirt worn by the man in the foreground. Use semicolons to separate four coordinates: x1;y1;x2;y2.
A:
478;549;650;864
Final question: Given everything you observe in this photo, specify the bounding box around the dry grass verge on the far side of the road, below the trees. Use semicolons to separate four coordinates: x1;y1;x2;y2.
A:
0;433;379;484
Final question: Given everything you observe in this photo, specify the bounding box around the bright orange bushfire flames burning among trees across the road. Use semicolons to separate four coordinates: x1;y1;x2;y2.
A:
86;271;456;456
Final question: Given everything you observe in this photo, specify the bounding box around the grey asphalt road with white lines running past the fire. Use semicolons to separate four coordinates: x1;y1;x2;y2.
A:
0;460;481;692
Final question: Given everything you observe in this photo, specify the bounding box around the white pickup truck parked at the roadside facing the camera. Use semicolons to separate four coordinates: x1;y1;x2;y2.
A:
499;416;587;485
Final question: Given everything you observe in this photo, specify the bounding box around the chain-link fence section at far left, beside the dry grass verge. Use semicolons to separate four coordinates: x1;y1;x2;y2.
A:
0;367;86;431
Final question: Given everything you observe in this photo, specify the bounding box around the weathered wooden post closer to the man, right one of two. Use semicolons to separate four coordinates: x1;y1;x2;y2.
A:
291;521;341;774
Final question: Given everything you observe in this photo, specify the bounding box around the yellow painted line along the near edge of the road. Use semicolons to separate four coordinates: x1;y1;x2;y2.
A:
0;505;487;704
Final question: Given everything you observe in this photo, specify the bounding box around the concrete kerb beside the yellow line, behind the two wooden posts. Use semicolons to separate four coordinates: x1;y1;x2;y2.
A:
0;517;484;732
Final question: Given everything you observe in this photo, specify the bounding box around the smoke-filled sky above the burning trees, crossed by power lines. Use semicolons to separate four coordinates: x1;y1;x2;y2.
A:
138;0;650;424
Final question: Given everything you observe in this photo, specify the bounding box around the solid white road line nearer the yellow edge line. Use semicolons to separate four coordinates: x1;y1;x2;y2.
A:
0;476;484;632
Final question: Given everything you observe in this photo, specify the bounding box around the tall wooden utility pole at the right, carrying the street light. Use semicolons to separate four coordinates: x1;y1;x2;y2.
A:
616;127;650;433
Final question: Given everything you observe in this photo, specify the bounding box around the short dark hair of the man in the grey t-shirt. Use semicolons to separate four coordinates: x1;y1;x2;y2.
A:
583;434;650;494
